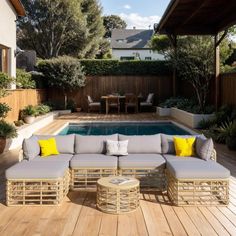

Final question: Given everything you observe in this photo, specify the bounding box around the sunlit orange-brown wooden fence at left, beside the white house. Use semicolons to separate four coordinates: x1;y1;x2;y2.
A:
0;89;47;122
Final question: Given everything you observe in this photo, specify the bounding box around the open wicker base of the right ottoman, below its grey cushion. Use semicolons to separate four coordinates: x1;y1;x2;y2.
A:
166;171;229;206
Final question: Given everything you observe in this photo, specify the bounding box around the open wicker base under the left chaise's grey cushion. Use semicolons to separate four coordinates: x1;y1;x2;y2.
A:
6;170;70;206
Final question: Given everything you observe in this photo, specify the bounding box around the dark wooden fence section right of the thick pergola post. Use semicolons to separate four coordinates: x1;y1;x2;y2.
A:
220;73;236;106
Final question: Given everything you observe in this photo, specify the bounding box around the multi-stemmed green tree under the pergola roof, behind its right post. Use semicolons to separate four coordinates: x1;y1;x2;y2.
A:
151;35;231;112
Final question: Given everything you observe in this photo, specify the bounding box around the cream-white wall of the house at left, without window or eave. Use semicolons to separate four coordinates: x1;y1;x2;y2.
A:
0;0;16;77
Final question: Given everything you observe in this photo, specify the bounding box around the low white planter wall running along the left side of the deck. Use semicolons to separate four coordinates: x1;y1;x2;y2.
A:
4;110;71;151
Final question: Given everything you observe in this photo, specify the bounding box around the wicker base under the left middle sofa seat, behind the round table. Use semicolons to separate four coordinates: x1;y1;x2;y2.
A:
70;168;117;190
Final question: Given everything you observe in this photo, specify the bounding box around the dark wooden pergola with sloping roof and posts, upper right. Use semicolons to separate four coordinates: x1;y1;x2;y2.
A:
155;0;236;107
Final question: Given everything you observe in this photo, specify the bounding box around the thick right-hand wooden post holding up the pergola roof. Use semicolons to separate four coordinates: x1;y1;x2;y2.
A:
214;34;220;110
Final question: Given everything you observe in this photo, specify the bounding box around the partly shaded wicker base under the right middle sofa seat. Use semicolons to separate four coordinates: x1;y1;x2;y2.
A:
119;167;166;191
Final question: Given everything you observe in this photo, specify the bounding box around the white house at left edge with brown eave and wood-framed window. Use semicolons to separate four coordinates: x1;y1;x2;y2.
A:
0;0;25;80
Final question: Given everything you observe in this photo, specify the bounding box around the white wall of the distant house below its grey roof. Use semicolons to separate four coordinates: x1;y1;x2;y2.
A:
112;49;164;60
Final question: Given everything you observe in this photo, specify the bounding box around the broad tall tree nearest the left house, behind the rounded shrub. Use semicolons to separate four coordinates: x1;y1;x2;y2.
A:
17;0;85;58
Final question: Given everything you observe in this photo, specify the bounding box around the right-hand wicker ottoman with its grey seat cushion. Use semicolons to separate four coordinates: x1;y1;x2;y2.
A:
167;158;230;206
